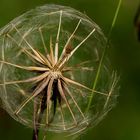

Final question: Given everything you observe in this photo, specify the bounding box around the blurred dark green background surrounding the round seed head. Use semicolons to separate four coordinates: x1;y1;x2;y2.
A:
0;0;140;140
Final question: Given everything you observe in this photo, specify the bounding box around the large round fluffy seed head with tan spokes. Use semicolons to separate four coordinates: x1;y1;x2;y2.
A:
0;5;118;136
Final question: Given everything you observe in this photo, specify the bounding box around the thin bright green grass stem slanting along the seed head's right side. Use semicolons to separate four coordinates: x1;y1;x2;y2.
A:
86;0;122;112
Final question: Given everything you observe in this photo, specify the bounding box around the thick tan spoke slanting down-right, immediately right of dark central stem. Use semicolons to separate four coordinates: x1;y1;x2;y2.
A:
58;79;77;125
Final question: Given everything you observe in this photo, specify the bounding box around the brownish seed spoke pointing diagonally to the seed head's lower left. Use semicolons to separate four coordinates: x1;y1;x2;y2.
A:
15;76;50;115
